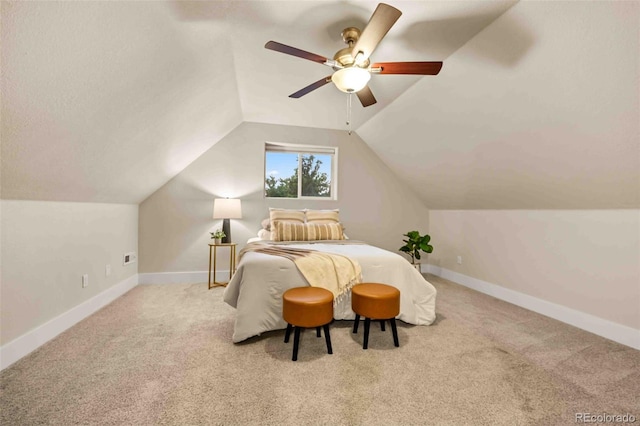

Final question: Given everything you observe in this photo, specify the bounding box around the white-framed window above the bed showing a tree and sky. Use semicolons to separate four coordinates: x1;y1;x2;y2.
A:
264;142;338;200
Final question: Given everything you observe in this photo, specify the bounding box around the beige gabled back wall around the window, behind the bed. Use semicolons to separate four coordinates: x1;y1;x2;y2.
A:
140;123;428;273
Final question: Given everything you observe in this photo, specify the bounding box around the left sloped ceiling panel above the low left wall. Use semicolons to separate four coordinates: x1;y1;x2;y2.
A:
2;1;242;203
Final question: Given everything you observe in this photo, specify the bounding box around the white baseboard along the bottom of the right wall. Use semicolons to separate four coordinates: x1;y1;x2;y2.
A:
422;265;640;350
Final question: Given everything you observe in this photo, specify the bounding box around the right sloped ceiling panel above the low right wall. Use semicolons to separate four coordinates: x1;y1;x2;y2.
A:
358;1;640;209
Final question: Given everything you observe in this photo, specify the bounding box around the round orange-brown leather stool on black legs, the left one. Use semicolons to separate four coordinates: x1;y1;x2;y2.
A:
282;287;333;361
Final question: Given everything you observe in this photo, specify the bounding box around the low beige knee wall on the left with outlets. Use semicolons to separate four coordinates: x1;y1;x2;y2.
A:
0;200;138;345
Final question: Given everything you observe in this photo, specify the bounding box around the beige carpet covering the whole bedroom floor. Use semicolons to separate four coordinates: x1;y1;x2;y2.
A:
0;276;640;425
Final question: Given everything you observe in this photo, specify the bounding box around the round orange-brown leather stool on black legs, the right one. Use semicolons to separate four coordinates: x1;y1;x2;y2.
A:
351;283;400;349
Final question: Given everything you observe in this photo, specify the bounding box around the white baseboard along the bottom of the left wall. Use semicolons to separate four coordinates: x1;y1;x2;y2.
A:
0;274;138;370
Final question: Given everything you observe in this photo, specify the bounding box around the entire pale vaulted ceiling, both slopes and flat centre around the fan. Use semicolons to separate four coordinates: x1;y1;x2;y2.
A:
1;1;640;208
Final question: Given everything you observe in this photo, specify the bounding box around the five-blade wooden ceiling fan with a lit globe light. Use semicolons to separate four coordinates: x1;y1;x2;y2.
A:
264;3;442;107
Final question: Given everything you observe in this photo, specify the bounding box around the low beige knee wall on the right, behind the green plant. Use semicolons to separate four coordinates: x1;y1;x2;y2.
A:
429;210;640;330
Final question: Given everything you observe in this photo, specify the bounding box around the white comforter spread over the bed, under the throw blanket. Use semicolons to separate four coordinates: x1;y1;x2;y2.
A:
224;243;436;342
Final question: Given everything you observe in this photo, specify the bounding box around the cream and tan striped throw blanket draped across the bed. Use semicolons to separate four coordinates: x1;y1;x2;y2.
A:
239;244;362;303
